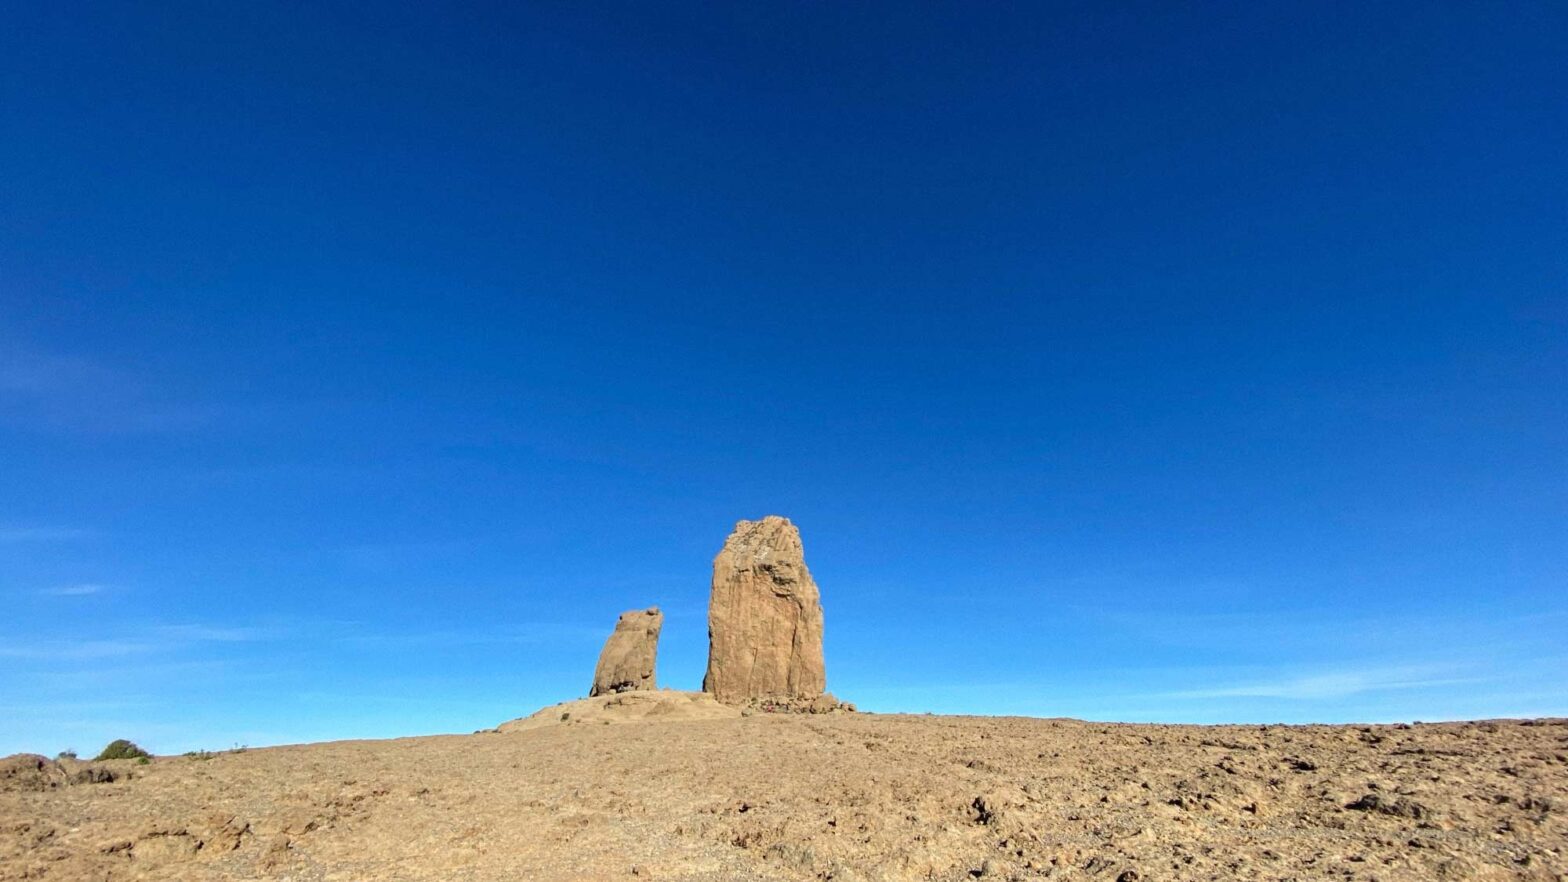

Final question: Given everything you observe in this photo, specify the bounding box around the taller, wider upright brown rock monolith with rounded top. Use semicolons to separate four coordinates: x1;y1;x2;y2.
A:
702;515;826;703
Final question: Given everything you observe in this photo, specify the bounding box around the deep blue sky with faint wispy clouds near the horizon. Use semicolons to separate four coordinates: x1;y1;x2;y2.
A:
0;3;1568;753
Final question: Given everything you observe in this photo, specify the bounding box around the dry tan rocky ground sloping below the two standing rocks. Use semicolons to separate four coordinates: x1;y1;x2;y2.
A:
0;692;1568;882
